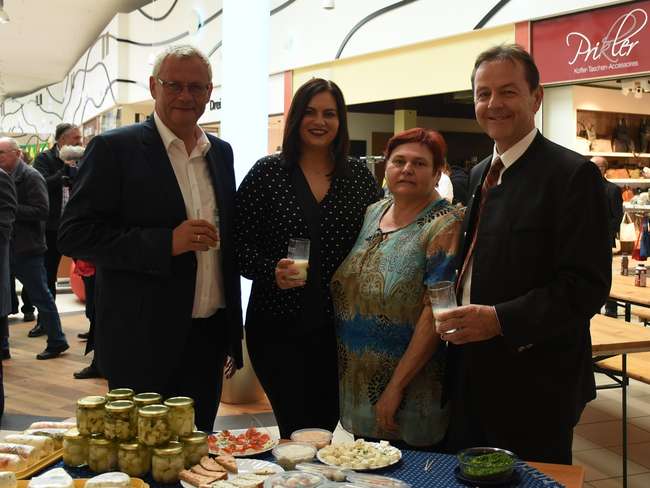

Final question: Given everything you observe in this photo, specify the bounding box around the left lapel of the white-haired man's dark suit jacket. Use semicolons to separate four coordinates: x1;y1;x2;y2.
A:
142;116;188;221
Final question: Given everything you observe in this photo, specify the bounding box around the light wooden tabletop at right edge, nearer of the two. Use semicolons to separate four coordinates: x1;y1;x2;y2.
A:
591;314;650;356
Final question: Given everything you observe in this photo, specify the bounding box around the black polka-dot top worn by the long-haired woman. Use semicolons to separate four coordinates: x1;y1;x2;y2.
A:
235;155;379;325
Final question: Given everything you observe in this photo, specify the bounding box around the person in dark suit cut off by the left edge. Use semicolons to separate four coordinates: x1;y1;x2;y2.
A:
0;168;17;420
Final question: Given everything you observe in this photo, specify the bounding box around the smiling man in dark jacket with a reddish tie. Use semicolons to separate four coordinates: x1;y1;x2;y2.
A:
436;45;611;464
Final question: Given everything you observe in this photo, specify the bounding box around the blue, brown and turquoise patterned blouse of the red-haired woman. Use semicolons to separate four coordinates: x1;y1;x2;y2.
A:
332;198;463;446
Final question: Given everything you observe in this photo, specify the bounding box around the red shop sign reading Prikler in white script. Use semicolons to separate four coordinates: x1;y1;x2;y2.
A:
532;1;650;83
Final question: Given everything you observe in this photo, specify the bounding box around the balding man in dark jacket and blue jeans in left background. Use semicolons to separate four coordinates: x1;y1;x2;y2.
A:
0;137;68;359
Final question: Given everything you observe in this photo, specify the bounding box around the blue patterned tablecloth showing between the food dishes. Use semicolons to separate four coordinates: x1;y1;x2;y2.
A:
44;449;563;488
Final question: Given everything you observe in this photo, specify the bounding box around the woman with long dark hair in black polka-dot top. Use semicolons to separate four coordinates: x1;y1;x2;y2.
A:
235;79;378;438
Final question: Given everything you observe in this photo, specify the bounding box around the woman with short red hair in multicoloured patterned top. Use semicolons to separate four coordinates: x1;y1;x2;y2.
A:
331;128;463;447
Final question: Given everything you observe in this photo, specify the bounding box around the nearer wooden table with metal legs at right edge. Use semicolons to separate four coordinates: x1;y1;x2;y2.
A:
591;314;650;488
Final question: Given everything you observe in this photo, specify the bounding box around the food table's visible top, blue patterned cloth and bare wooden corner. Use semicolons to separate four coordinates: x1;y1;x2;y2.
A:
38;449;584;488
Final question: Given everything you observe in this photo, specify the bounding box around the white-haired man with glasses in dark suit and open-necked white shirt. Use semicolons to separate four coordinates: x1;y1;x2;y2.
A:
59;46;242;430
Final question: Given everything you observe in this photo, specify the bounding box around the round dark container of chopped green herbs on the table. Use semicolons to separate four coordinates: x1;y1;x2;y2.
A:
457;447;517;483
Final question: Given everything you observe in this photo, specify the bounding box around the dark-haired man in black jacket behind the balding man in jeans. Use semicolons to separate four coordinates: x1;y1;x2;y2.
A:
29;123;81;337
